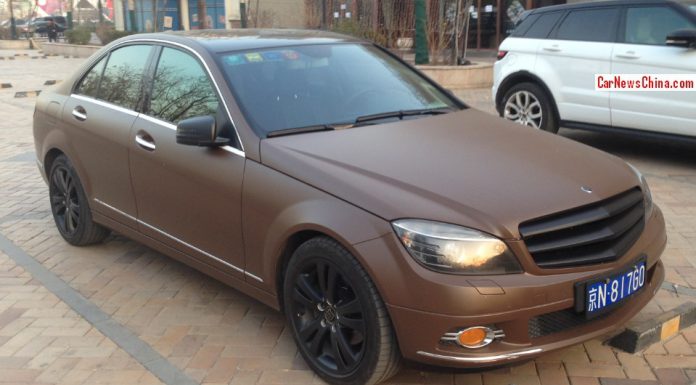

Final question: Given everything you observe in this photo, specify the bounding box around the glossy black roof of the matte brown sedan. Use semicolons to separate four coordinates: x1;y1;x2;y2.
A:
124;29;364;52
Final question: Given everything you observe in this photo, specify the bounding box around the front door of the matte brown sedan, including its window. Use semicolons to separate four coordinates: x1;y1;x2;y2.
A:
130;47;245;278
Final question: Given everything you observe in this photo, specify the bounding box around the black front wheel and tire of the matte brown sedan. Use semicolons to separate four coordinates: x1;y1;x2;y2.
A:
283;237;401;385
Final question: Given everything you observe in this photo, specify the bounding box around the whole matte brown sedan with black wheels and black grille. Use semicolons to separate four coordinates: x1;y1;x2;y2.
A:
34;30;666;384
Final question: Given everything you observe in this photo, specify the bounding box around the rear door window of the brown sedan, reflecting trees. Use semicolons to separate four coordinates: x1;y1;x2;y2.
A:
98;45;152;110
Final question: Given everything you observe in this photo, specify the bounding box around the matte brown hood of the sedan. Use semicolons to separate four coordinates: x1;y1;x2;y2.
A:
261;109;639;239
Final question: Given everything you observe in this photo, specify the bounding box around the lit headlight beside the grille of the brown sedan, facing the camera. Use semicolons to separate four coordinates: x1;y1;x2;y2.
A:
392;219;522;275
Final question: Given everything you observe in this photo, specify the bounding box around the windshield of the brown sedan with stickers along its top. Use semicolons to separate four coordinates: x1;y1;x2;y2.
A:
219;44;459;137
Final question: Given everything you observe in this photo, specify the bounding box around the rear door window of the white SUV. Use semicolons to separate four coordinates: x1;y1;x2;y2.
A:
556;8;619;42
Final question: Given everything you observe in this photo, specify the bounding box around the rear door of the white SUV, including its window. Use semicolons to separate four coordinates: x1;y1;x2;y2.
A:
535;7;619;125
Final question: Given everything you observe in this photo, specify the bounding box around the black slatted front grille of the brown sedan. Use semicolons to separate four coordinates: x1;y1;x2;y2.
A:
520;188;645;268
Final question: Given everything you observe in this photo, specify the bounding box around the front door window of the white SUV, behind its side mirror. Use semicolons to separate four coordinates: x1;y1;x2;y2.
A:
626;7;696;45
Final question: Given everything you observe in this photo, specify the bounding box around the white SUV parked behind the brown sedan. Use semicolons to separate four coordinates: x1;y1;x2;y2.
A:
493;0;696;139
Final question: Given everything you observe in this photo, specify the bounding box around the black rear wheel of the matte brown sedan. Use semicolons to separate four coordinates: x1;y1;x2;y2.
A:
48;155;109;246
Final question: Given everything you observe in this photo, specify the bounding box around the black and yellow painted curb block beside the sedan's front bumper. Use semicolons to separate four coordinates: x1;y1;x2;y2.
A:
609;302;696;353
